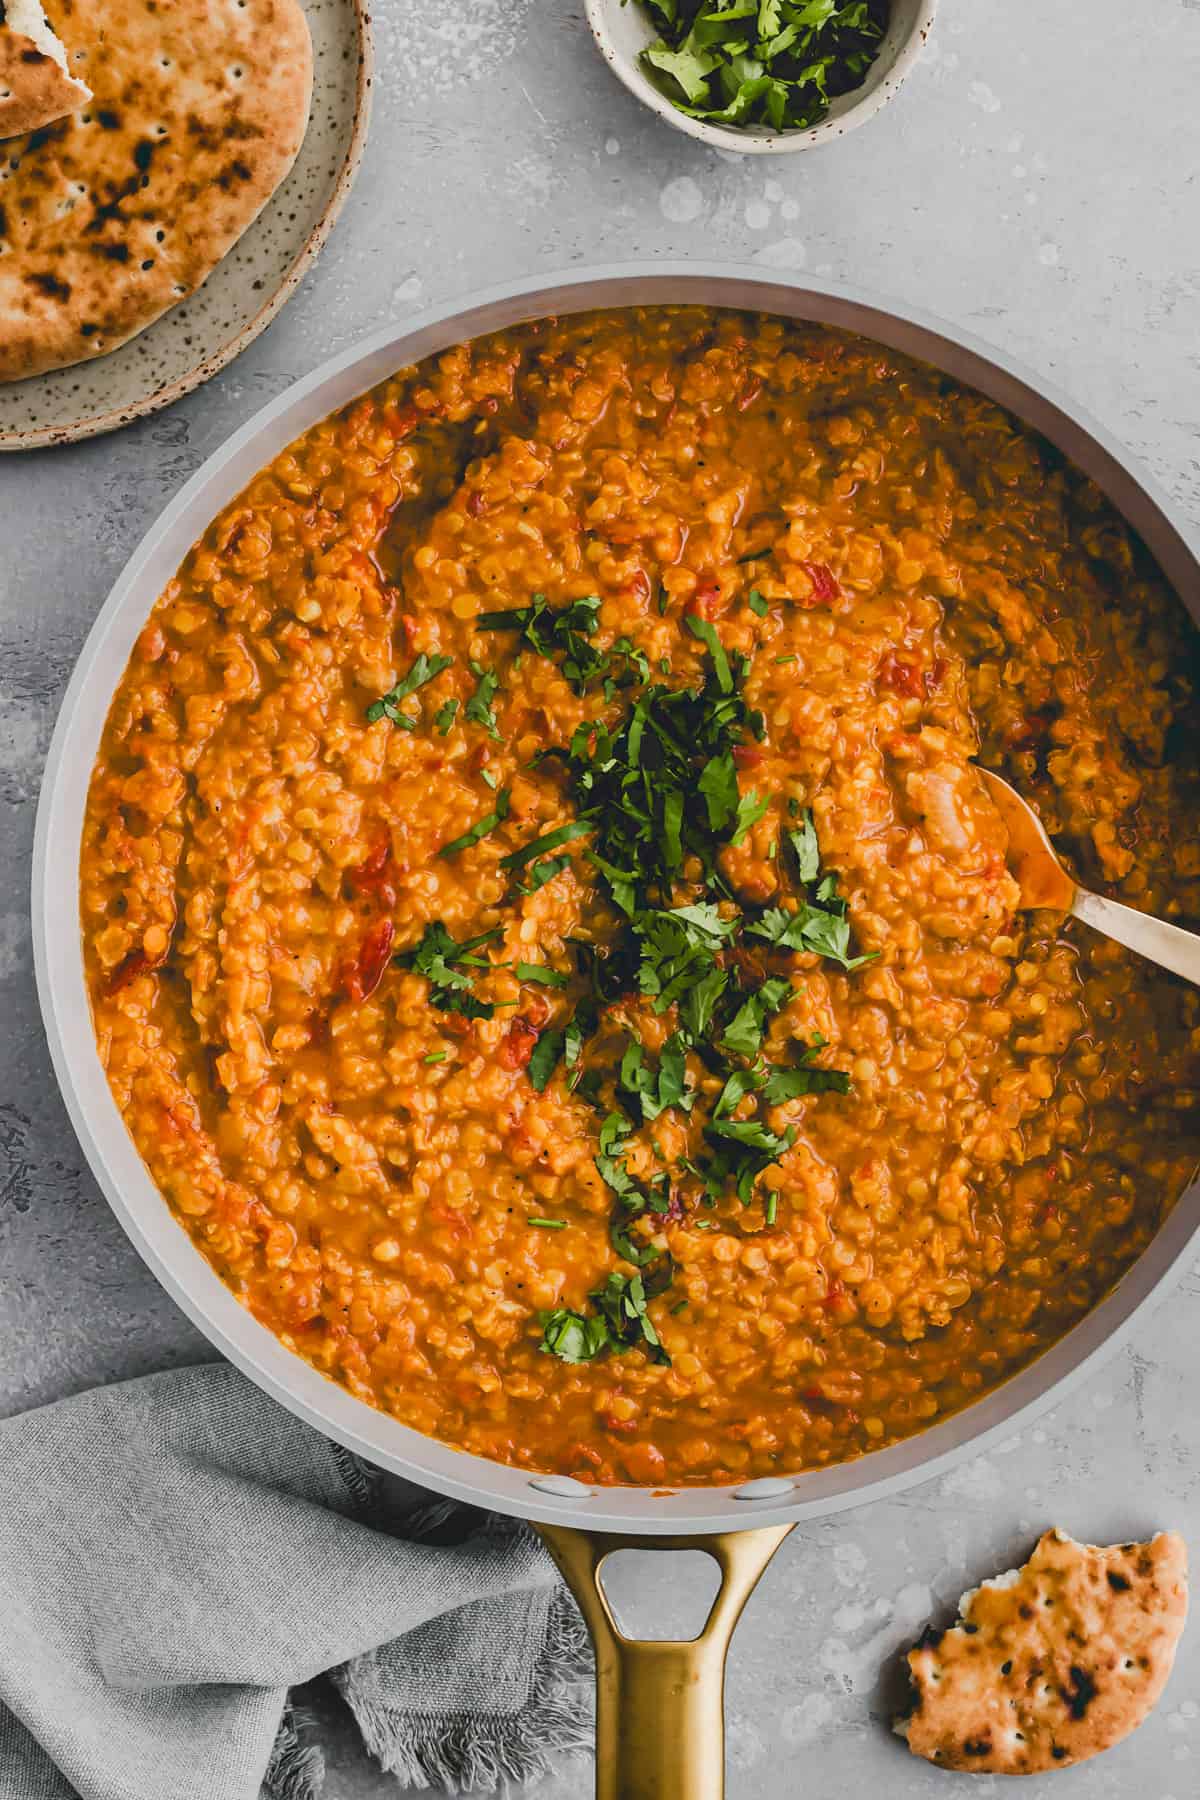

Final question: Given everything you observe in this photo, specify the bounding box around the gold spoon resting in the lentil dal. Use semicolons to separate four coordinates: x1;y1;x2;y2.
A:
975;765;1200;986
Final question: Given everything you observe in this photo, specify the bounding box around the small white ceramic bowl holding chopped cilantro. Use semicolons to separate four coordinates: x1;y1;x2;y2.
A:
585;0;937;157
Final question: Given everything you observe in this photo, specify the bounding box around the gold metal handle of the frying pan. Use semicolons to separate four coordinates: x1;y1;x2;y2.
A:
538;1525;792;1800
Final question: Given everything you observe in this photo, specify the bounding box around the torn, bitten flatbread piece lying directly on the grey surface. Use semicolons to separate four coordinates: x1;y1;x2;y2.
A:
896;1532;1187;1775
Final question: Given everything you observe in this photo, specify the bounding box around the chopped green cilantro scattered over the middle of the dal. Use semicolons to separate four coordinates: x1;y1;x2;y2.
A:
390;576;867;1363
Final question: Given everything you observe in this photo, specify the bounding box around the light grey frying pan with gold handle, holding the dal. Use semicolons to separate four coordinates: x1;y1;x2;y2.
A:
32;263;1200;1800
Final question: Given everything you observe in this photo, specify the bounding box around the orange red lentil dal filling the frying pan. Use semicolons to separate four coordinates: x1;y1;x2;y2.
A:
81;308;1200;1485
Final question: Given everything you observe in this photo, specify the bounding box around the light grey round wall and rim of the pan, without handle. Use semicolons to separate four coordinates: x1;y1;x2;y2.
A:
32;263;1200;1535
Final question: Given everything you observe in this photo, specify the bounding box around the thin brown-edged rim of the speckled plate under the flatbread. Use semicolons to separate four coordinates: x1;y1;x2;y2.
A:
0;0;374;452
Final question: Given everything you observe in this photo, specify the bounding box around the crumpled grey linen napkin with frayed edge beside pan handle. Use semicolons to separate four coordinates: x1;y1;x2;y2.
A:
0;1363;588;1800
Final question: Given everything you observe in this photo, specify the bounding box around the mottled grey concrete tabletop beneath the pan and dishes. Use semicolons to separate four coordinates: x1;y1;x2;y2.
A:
0;0;1200;1800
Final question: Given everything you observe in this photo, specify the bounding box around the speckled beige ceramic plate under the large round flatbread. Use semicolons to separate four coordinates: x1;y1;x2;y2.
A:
0;0;372;450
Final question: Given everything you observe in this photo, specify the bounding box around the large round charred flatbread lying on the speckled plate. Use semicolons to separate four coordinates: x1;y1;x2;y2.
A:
0;0;313;382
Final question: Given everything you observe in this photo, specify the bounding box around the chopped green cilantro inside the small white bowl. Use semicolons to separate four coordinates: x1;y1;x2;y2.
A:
637;0;887;131
